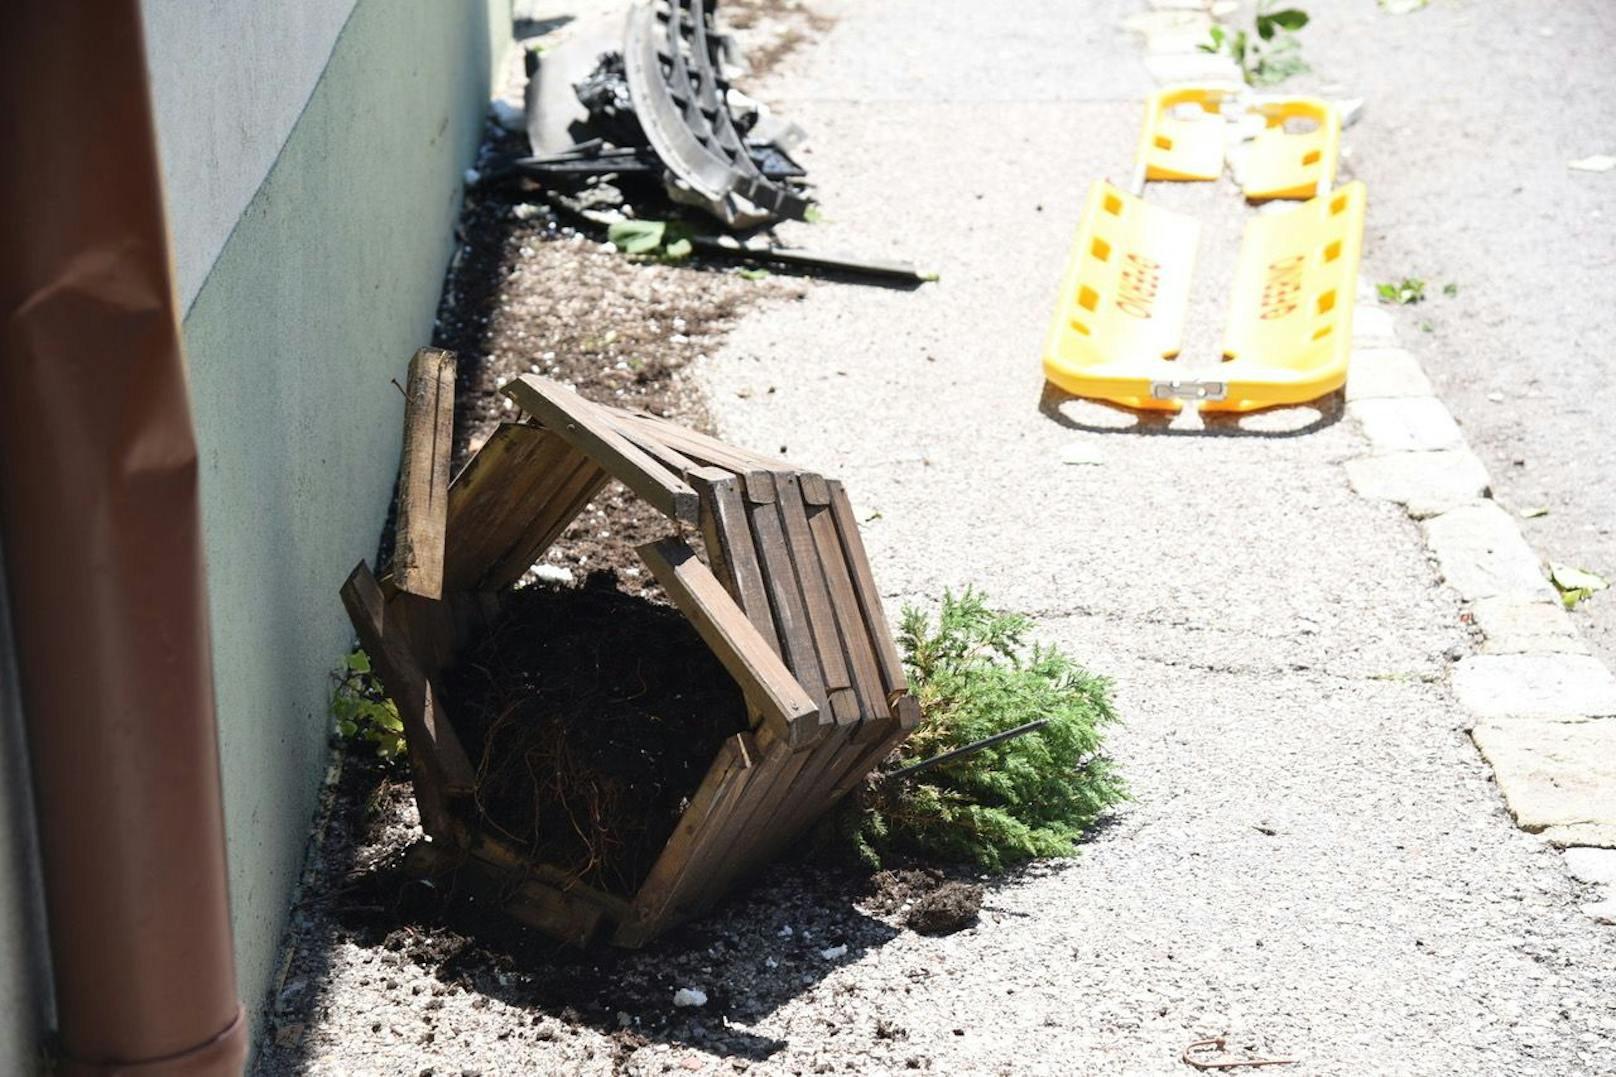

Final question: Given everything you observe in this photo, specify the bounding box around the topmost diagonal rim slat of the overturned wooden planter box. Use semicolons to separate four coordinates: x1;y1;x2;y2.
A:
504;374;701;524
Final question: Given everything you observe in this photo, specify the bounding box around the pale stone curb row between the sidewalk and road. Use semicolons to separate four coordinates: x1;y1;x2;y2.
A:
1345;299;1616;923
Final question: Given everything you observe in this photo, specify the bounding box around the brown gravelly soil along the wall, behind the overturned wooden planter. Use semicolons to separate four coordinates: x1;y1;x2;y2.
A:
433;131;810;593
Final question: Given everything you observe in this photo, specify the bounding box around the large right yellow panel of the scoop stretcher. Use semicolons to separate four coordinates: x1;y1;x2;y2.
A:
1206;183;1366;411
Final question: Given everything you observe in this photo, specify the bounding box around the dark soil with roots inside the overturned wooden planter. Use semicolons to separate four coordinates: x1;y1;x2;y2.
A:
443;571;747;896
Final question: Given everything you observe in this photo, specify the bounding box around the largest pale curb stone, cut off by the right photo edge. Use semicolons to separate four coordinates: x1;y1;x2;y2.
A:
1471;720;1616;836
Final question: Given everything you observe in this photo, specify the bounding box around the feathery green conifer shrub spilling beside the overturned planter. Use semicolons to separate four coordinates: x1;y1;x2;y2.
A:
845;589;1128;870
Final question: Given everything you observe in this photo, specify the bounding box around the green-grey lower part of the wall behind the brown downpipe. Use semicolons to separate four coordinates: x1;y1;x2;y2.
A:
171;0;509;1034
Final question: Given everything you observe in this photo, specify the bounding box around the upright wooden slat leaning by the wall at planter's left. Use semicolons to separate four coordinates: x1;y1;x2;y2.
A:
393;348;454;598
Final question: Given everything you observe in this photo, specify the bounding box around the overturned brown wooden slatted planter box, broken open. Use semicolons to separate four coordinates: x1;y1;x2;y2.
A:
343;349;920;946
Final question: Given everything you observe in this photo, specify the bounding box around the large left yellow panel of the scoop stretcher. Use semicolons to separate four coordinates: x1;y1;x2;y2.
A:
1044;180;1201;409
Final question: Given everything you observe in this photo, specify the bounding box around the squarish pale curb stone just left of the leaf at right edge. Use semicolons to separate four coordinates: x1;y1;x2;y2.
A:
1425;501;1555;602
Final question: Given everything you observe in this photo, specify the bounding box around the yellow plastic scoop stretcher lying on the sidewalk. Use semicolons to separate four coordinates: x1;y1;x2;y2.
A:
1044;87;1366;411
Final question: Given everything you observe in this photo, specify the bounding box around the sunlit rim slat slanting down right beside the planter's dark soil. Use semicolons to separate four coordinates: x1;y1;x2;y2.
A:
638;539;819;745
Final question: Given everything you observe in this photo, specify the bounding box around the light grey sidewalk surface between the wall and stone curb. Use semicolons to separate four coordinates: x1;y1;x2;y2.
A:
259;0;1616;1075
